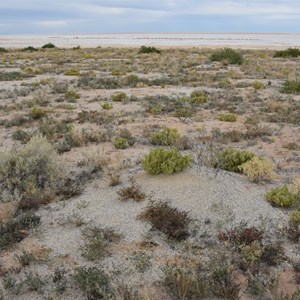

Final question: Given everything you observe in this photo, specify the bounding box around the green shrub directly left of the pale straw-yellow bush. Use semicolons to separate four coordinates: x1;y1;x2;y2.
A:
214;148;255;173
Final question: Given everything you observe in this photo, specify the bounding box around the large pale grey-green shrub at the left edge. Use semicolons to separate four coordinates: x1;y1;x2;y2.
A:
0;136;64;200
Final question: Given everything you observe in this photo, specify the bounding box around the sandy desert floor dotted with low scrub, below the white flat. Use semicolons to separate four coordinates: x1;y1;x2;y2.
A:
0;47;300;300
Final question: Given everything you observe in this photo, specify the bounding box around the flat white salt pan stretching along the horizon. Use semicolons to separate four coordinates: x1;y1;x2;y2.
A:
0;32;300;49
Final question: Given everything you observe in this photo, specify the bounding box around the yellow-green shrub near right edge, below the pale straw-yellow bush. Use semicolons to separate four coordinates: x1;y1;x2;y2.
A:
265;184;297;207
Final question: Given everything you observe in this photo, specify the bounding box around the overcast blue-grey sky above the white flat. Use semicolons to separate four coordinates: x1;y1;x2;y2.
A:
0;0;300;34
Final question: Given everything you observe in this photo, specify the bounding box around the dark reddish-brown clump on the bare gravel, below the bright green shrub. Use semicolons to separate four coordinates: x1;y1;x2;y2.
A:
139;202;191;241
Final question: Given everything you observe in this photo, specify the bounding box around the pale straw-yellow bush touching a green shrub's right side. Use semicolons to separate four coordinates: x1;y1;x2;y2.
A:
240;156;273;182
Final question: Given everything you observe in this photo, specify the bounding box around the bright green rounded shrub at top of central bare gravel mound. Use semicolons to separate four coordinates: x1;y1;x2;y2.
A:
142;147;192;175
